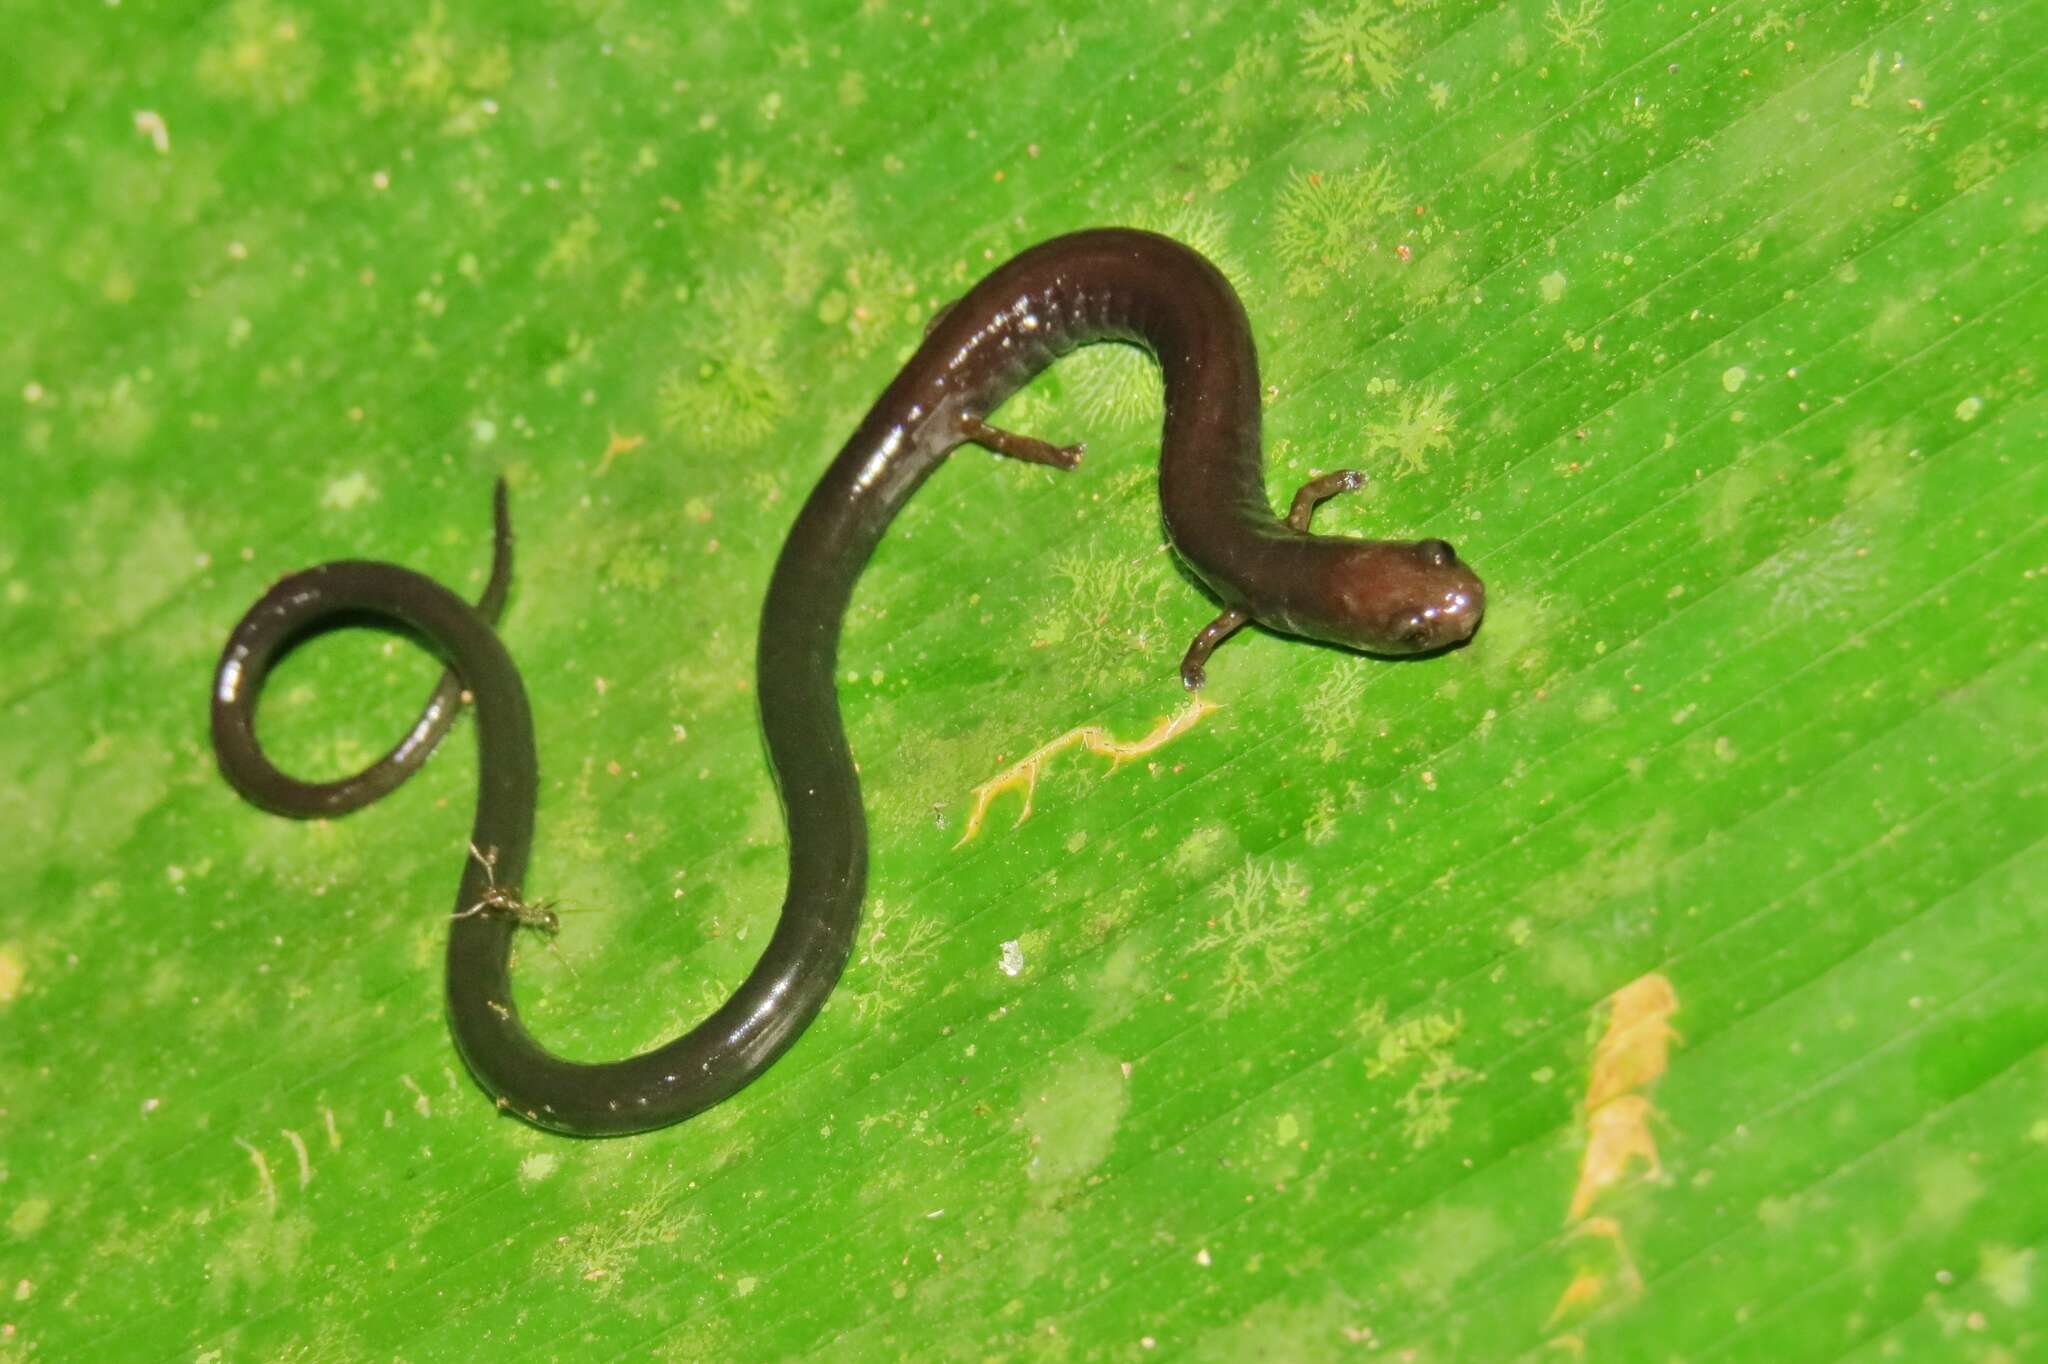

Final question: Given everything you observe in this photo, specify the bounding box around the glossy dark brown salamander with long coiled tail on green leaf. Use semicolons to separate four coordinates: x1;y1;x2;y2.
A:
213;229;1485;1137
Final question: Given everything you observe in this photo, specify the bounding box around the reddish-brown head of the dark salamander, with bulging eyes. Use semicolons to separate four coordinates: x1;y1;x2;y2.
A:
1309;541;1487;653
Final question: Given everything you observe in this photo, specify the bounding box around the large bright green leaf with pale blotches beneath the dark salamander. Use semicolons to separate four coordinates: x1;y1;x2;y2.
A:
0;0;2048;1362
